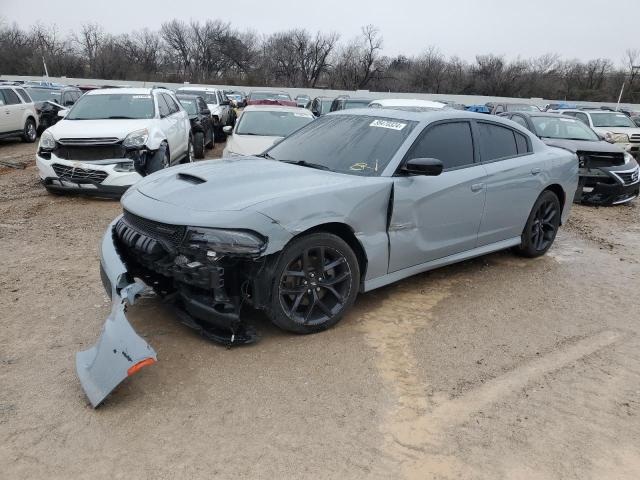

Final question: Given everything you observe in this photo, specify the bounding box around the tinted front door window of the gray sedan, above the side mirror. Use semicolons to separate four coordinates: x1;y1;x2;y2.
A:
406;121;473;170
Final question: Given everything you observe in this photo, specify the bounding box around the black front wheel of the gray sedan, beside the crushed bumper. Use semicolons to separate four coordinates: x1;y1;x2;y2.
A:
268;233;360;334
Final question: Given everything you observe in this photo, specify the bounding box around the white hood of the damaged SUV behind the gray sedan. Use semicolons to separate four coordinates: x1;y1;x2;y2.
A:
49;119;149;140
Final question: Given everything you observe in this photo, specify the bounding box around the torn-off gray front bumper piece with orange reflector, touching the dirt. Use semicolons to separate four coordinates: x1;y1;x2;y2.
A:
76;219;157;408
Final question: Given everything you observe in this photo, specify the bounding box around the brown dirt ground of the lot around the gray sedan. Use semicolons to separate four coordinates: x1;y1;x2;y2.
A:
0;137;640;480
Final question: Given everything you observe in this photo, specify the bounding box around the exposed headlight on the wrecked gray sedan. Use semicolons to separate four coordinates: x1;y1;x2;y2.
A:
187;227;267;258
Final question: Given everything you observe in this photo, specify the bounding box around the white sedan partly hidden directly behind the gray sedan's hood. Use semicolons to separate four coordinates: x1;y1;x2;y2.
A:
222;105;315;157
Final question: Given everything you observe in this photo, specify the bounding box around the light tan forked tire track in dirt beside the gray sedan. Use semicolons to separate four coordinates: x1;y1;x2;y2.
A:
358;278;627;480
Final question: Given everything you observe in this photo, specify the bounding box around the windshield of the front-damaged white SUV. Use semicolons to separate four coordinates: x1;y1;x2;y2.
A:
65;93;155;120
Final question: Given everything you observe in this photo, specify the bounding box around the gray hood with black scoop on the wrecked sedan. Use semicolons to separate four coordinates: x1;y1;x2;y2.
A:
132;157;382;212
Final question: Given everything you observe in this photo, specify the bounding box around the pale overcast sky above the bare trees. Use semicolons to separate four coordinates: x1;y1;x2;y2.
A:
0;0;640;64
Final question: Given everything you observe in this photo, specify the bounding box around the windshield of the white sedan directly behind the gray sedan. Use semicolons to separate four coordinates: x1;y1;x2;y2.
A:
236;111;313;137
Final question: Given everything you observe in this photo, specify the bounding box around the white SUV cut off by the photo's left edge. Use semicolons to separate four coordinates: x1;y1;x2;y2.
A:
0;85;38;142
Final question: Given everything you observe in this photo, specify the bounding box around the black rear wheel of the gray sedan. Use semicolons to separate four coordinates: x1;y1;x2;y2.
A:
516;190;562;258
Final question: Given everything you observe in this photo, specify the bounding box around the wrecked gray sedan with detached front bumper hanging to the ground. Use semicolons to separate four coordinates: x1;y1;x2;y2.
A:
76;109;578;405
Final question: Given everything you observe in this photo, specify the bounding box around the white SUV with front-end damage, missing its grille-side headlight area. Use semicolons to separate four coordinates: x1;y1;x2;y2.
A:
36;88;193;197
